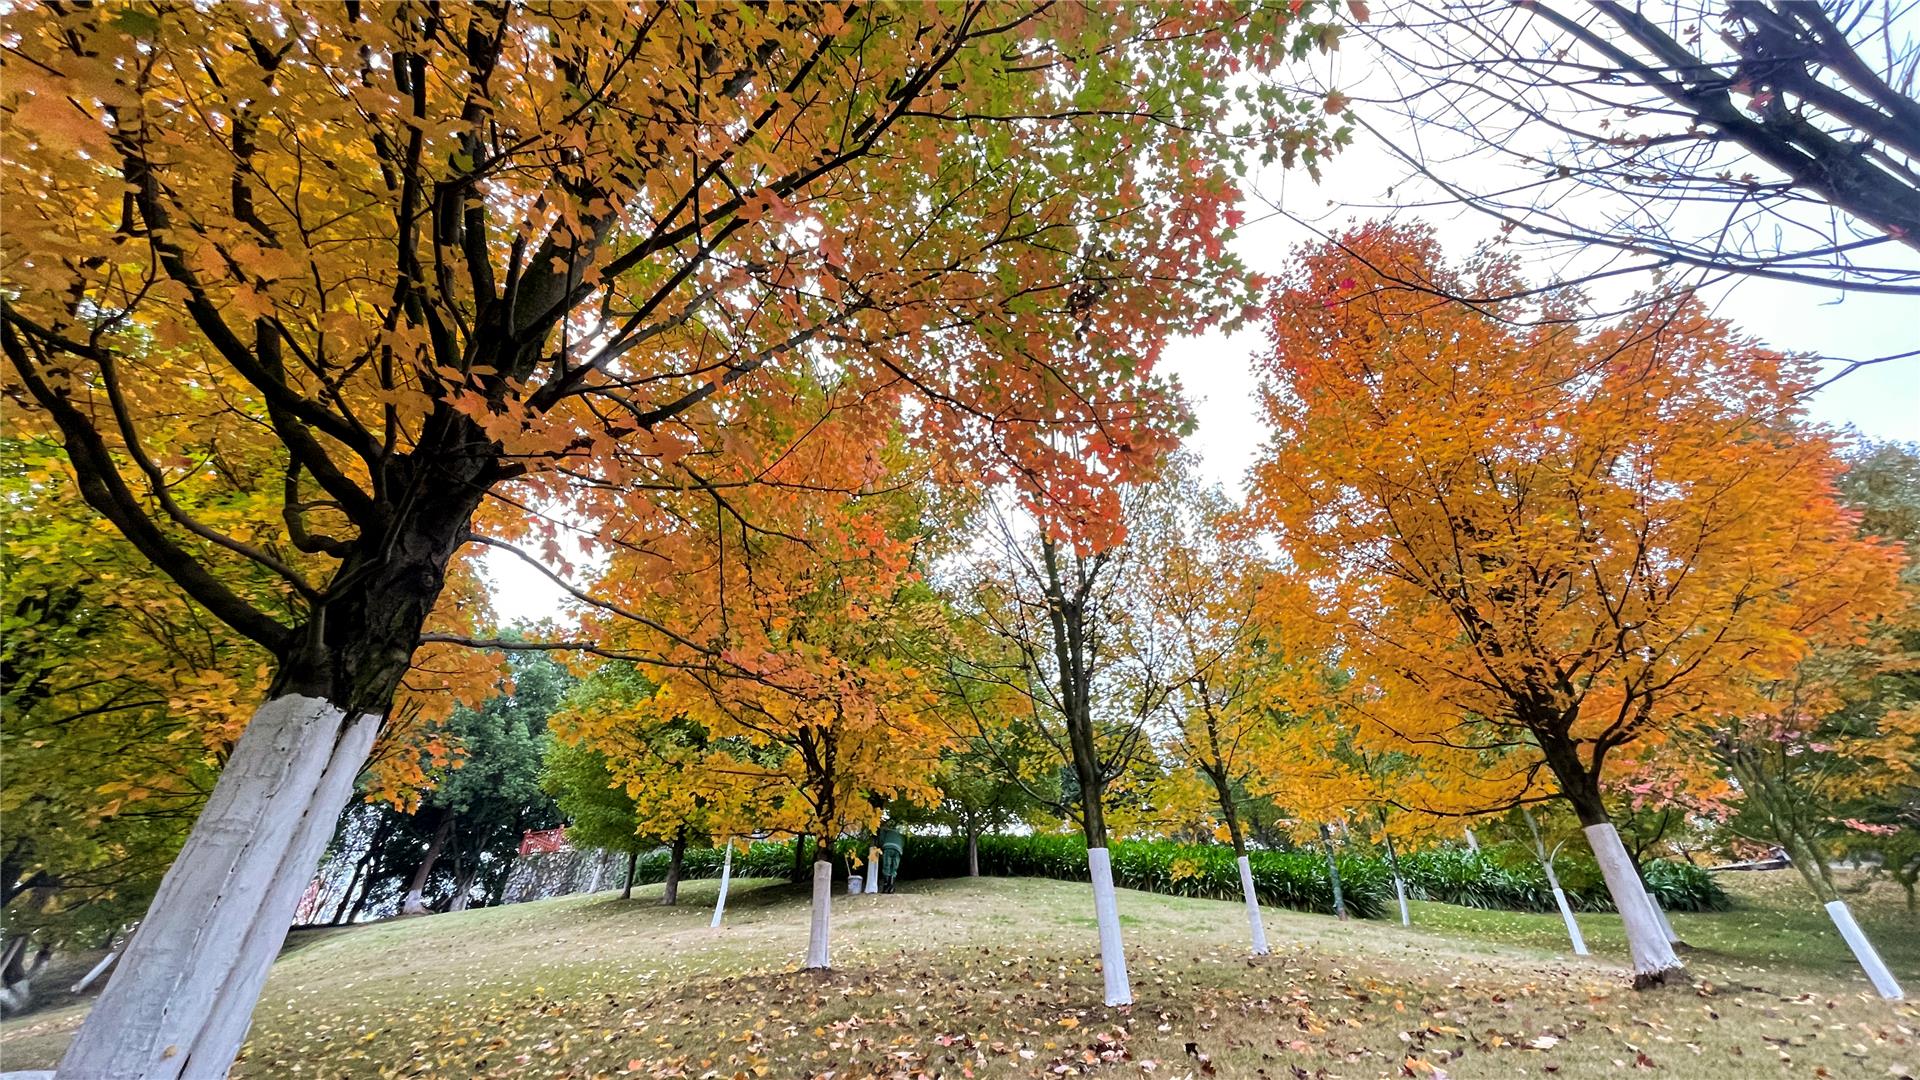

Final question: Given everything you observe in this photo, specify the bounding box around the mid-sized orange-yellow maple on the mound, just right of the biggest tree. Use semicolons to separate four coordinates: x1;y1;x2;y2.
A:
563;395;947;967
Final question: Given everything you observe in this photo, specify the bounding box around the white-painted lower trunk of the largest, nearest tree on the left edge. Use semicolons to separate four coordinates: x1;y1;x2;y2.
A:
58;694;380;1080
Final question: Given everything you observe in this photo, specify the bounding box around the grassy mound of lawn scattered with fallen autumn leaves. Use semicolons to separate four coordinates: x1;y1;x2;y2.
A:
0;872;1920;1080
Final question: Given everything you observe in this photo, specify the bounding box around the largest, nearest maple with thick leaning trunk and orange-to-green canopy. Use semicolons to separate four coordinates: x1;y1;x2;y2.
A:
0;2;1334;1076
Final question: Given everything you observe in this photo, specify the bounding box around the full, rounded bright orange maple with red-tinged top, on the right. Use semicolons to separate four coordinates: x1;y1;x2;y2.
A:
1252;225;1899;980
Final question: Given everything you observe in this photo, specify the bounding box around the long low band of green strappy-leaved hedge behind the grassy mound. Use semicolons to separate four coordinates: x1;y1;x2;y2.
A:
618;834;1726;919
